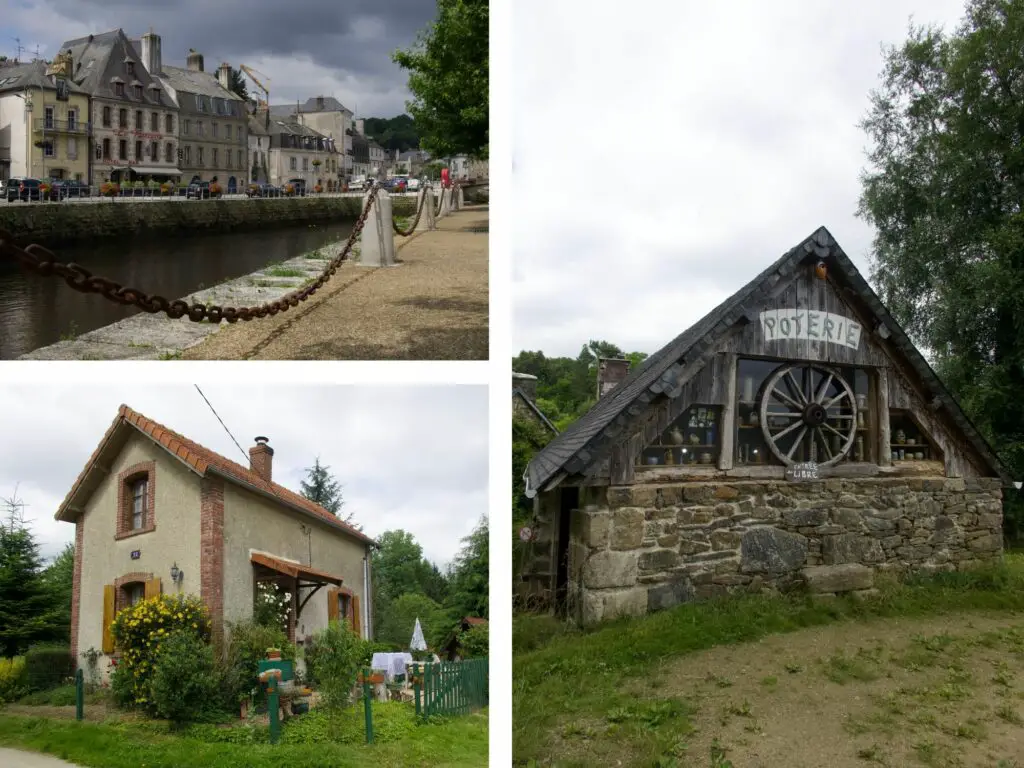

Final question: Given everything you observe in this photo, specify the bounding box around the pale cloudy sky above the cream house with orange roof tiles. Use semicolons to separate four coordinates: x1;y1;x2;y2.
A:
0;382;487;568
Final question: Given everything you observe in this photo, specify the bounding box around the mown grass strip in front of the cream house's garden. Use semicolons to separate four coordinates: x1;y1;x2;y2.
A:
0;703;487;768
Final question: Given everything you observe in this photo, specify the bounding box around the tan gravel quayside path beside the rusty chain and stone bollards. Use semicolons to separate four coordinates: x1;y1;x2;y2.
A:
182;206;489;360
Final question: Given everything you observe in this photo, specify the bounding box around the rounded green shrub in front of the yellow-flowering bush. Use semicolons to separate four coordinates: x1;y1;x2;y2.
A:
150;630;219;723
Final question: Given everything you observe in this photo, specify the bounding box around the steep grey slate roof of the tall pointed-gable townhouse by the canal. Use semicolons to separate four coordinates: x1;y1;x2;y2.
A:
59;29;174;109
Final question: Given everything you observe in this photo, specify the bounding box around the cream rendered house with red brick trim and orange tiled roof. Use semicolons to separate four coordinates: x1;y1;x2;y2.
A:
55;406;374;669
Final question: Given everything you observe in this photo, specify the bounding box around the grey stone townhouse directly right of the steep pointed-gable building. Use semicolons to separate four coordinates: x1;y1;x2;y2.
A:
143;43;249;194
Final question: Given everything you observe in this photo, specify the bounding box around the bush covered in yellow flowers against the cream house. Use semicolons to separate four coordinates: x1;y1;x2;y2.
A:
111;595;210;710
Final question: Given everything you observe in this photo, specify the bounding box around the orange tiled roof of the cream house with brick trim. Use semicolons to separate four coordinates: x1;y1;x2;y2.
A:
54;406;374;544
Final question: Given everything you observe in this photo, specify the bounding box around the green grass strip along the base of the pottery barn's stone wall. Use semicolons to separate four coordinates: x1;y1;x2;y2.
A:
512;555;1024;766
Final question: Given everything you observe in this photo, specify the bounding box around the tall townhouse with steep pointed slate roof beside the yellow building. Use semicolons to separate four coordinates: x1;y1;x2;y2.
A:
60;29;180;184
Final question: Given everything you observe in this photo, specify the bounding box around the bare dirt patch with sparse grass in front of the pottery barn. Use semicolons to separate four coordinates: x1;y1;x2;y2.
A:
624;614;1024;768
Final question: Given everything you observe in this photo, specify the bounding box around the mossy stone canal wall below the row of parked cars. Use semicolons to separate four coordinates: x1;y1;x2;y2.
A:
0;197;416;247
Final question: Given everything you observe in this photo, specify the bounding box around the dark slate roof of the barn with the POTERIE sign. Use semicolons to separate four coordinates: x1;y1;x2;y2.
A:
524;226;1011;496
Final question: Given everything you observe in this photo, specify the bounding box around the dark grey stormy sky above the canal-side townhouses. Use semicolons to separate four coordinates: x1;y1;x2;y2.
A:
0;0;437;118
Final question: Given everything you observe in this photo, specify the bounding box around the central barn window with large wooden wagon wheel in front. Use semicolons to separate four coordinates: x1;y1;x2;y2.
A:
733;359;878;466
